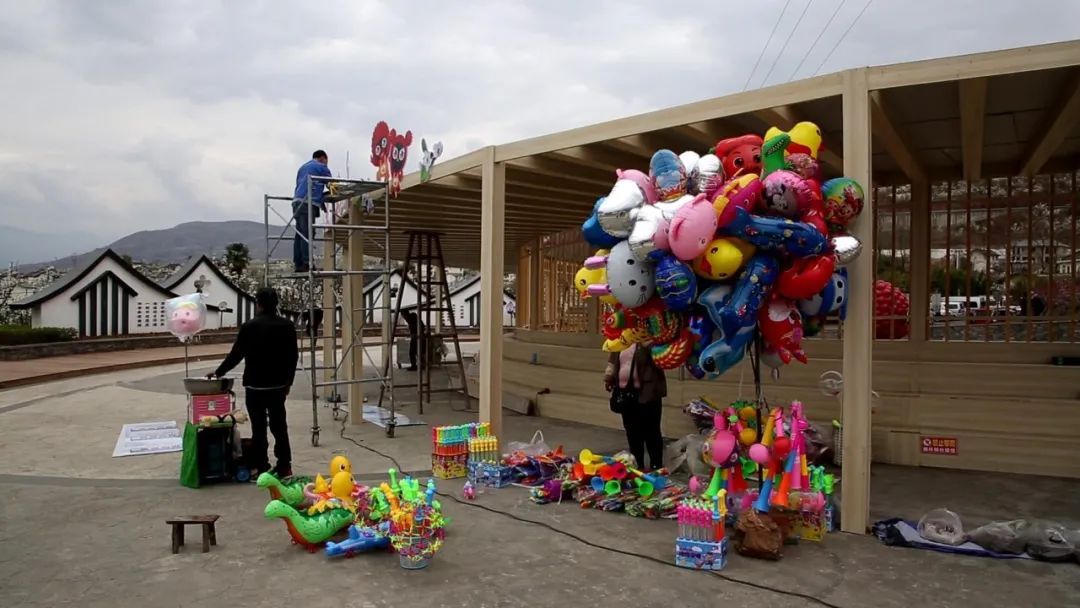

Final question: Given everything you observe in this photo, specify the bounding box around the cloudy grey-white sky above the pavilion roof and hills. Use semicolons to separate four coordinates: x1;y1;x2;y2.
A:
0;0;1080;239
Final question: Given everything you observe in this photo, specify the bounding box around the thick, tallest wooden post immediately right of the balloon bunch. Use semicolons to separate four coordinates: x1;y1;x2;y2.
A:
840;68;874;535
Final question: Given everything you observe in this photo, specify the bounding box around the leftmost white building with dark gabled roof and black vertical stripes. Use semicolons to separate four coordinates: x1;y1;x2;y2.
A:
12;249;230;338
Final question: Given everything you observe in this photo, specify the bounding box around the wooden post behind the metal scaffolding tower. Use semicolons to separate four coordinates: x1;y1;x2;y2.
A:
341;201;365;424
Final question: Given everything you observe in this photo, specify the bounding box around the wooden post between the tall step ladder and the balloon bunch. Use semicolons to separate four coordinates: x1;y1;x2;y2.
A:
480;147;507;436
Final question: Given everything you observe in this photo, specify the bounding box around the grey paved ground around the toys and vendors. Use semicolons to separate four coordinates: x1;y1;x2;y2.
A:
0;352;1080;608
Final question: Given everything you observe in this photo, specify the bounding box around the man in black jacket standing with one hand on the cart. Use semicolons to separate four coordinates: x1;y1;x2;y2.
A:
208;287;300;477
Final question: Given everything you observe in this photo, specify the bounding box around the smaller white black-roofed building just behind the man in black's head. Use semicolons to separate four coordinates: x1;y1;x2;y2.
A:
161;255;255;327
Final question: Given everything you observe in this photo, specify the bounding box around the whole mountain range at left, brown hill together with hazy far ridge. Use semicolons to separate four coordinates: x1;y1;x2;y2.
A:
11;220;293;272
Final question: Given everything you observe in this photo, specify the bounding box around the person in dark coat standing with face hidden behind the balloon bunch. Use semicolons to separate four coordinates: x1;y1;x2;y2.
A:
604;344;667;471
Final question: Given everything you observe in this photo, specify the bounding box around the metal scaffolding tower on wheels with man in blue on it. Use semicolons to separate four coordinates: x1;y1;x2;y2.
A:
262;176;397;446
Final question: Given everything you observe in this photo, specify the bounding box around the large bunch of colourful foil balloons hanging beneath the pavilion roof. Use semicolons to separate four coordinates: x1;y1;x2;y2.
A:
575;122;863;379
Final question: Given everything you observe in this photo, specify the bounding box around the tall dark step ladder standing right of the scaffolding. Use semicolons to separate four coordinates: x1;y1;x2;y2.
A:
379;230;472;414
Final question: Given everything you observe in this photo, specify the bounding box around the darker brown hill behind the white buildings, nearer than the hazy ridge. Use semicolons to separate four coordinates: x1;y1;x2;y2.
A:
19;220;293;272
